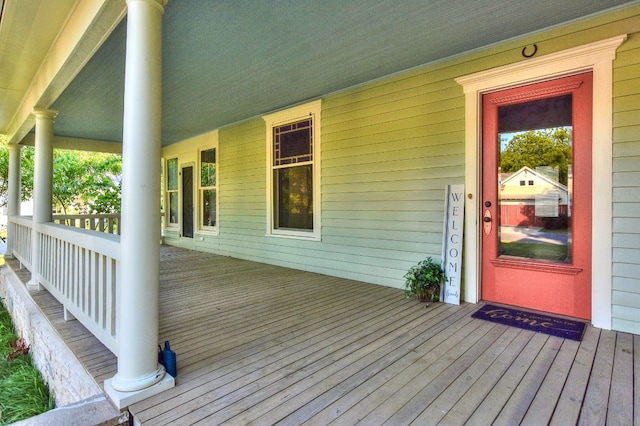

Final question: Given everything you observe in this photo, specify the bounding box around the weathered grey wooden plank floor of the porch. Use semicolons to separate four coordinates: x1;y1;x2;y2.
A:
13;246;640;425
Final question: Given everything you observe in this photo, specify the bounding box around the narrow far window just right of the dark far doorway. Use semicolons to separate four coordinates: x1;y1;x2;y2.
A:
198;148;218;231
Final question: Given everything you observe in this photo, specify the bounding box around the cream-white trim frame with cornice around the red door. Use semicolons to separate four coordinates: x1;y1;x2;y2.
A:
456;34;627;329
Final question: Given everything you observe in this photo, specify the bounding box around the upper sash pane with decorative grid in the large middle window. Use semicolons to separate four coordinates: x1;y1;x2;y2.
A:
273;120;313;166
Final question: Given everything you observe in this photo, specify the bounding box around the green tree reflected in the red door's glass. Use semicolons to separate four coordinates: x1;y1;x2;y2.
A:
500;127;573;185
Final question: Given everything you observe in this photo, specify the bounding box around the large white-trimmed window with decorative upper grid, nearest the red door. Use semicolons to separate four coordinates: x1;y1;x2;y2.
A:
263;101;320;240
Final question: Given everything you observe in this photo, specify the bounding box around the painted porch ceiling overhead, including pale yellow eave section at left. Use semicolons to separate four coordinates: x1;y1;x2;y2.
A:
0;0;638;146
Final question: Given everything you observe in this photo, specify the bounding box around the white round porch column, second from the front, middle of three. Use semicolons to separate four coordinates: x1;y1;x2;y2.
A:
27;109;58;288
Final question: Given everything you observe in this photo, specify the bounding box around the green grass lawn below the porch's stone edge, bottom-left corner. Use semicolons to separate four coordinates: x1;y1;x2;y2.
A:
0;300;54;425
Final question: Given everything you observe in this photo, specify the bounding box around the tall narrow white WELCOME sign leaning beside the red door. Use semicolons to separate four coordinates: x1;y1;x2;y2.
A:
441;184;464;305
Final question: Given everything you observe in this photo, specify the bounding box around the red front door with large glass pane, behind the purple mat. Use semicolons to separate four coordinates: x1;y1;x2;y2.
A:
481;73;592;319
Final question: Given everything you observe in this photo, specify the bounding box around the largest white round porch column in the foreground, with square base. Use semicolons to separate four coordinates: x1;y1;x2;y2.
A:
105;0;174;407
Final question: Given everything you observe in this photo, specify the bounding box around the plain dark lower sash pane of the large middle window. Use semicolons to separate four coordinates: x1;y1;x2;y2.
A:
274;164;313;230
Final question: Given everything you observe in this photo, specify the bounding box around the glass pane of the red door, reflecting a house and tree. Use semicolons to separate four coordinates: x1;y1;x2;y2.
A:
497;95;574;263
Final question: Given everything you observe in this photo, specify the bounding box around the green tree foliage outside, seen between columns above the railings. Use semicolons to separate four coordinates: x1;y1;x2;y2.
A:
0;139;122;214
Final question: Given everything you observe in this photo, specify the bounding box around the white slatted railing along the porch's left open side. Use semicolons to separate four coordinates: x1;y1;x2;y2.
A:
9;217;120;355
